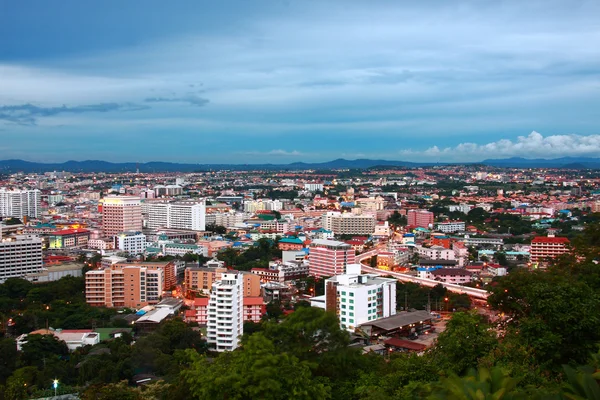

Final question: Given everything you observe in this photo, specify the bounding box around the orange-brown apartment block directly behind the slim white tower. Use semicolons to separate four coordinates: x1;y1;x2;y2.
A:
184;267;260;297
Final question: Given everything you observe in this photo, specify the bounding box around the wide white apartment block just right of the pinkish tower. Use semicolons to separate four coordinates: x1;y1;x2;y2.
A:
144;201;206;231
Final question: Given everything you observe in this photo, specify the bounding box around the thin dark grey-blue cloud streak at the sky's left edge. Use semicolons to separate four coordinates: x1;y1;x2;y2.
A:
0;103;148;125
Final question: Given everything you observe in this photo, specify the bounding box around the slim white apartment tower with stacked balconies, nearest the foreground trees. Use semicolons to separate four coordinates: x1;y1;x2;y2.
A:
206;273;244;352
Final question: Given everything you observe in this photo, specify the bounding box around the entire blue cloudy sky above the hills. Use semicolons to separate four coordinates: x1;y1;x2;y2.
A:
0;0;600;163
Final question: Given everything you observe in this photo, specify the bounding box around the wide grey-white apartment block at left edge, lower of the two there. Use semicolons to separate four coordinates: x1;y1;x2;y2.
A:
0;235;43;283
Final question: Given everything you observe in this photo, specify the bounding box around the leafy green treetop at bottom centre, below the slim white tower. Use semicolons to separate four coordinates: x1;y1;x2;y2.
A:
183;332;331;400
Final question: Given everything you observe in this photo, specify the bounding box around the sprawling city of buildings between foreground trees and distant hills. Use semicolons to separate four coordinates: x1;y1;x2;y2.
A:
0;165;600;398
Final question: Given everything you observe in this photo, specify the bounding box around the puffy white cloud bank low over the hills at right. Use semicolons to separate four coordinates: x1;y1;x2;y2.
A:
400;131;600;161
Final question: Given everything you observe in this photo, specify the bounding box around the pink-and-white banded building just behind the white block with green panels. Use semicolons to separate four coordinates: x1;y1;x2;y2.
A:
308;239;356;278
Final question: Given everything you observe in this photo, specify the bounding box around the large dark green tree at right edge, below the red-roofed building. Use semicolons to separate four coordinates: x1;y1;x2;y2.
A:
488;270;600;372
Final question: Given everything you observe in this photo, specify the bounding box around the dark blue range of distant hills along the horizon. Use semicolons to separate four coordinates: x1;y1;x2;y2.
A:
0;157;600;173
